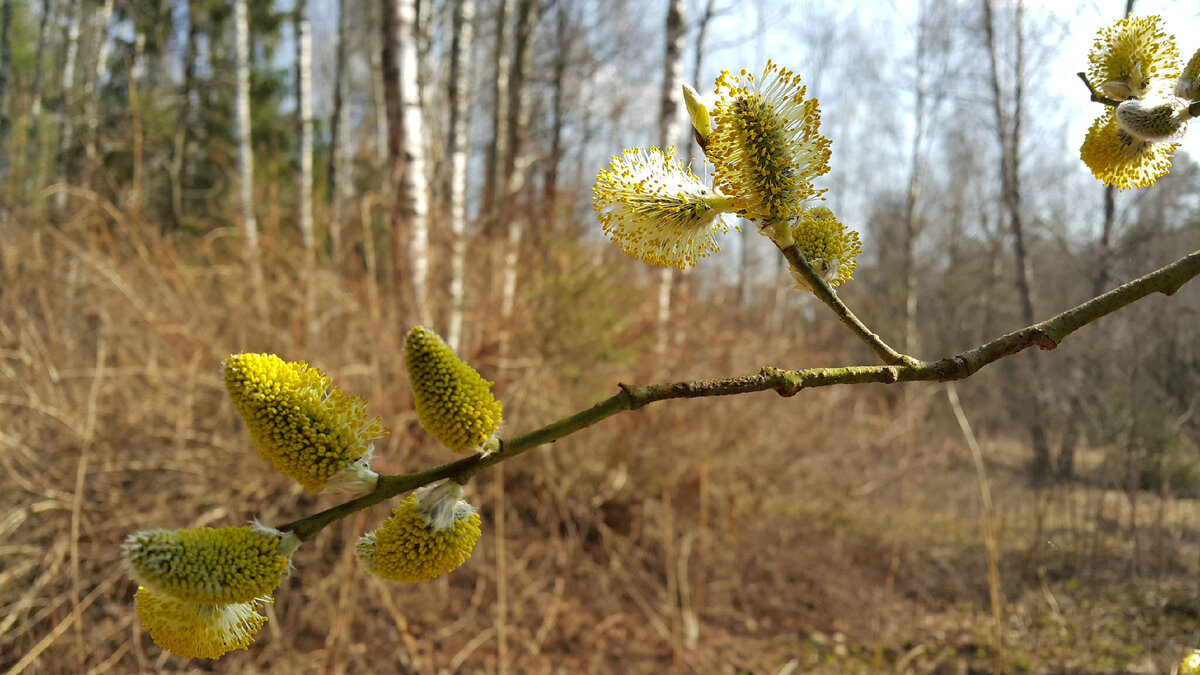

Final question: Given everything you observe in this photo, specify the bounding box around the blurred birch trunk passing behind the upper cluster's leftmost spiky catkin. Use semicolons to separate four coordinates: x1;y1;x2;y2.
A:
654;0;698;364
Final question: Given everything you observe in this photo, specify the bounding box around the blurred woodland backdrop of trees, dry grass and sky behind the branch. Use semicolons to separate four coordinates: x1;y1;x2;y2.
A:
0;0;1200;674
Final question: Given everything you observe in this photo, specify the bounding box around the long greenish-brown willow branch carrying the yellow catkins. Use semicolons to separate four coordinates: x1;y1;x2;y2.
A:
280;246;1200;539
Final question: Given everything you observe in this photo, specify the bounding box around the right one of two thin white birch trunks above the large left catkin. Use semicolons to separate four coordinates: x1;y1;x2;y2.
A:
295;0;320;346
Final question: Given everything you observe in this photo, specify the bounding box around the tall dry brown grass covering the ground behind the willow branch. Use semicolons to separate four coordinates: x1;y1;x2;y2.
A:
0;201;1200;674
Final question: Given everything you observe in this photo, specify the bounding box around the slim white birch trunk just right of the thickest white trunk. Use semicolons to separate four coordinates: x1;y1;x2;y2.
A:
446;0;475;352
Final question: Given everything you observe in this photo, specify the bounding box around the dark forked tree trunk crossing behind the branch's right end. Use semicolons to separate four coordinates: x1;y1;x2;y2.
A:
983;0;1051;485
